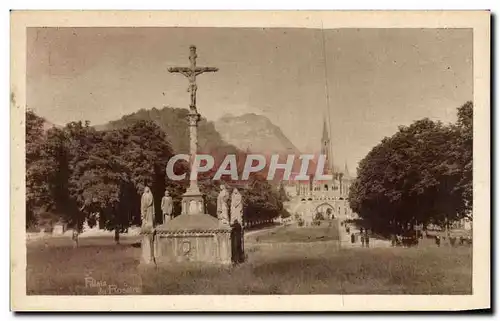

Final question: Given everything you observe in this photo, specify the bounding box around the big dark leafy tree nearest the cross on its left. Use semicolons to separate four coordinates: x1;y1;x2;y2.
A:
75;121;176;242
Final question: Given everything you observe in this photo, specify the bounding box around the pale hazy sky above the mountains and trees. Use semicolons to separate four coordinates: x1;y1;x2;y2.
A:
26;28;473;172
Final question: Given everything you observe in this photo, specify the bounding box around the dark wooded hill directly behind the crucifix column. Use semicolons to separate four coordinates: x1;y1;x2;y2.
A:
94;107;242;155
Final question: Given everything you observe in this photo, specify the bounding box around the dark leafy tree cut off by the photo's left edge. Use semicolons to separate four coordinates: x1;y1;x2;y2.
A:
26;116;88;229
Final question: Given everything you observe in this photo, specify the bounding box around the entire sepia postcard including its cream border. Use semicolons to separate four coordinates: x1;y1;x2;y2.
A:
10;11;490;311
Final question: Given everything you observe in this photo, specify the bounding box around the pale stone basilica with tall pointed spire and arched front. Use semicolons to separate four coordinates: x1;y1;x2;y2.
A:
284;116;356;222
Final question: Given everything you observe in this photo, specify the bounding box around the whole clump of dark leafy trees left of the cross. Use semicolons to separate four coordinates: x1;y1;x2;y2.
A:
26;112;177;240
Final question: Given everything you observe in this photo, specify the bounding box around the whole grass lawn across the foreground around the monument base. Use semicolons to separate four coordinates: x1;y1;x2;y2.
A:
27;229;472;295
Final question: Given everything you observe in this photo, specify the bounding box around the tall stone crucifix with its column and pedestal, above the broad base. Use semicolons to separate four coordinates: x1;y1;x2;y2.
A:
168;46;219;214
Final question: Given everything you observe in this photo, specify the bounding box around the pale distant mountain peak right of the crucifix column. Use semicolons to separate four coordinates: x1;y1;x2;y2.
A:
215;113;299;155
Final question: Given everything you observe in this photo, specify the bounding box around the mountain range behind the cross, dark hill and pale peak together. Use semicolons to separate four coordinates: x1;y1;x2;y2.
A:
94;107;300;181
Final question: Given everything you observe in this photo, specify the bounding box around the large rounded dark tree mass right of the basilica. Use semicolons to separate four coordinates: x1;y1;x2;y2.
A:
349;103;471;233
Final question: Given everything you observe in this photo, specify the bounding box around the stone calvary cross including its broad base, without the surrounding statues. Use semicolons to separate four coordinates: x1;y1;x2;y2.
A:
141;46;231;266
